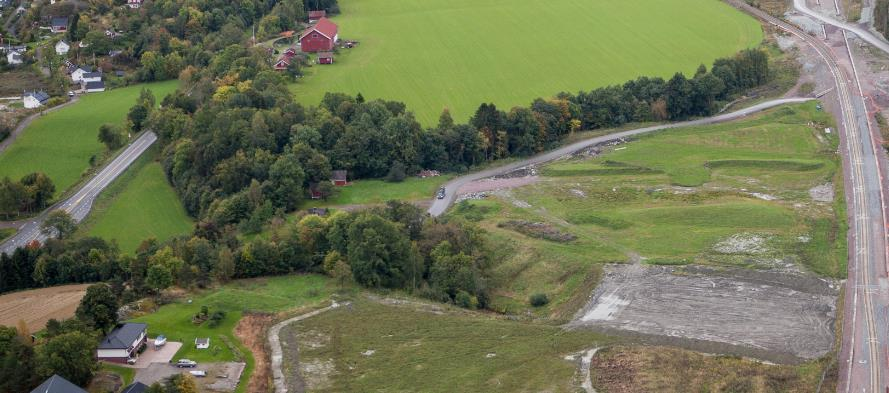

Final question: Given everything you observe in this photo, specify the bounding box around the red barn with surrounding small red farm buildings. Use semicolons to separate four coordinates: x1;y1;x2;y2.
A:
275;11;339;71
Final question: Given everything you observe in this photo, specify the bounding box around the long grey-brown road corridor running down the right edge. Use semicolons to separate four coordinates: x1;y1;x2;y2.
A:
730;0;889;393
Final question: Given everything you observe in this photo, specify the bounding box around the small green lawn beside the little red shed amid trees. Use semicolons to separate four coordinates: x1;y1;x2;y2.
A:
308;175;453;207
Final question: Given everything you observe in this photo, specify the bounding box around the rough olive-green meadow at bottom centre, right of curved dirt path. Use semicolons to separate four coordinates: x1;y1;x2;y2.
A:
282;299;604;392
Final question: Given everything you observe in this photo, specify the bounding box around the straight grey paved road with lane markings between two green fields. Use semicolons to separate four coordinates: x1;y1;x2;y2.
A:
0;131;157;254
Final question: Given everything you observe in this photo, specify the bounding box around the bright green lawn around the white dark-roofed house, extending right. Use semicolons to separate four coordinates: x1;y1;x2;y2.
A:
134;275;333;390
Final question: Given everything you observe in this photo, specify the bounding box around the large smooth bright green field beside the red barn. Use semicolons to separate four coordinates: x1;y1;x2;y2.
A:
292;0;763;125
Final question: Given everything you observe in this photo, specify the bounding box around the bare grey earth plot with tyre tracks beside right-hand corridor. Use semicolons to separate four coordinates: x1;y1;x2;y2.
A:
569;264;837;363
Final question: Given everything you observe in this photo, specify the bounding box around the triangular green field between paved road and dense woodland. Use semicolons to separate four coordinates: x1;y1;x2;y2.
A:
80;147;192;252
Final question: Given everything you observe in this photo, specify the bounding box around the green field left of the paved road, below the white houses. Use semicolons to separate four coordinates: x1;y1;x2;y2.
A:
0;81;178;195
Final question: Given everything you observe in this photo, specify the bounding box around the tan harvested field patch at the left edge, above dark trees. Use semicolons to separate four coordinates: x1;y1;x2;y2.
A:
0;284;89;333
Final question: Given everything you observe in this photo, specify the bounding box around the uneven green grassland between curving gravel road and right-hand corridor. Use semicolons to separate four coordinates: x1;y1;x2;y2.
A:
452;103;846;318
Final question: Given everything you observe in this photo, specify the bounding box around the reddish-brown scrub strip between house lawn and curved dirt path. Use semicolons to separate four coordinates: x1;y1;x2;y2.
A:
235;313;275;393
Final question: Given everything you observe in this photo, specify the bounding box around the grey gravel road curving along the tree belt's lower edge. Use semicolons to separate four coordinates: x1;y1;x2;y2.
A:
428;98;811;217
